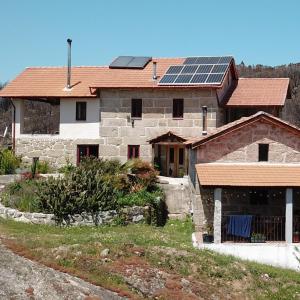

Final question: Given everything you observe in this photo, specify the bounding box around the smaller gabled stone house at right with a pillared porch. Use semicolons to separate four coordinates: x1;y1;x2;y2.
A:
185;112;300;243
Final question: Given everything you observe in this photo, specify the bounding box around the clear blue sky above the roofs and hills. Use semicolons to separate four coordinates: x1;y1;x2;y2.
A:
0;0;300;83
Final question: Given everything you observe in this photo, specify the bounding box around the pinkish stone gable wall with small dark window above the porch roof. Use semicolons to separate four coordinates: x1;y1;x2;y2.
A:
197;122;300;163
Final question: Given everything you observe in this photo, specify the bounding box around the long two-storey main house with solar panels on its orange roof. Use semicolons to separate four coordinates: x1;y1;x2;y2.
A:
0;56;289;177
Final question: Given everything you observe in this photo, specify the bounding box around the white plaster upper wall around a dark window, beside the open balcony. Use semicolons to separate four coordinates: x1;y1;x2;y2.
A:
59;98;100;139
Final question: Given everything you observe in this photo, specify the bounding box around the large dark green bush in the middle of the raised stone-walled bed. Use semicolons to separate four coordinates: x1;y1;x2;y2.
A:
38;159;120;224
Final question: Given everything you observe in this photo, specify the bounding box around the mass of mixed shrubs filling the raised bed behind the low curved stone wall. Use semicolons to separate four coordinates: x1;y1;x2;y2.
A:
3;159;166;225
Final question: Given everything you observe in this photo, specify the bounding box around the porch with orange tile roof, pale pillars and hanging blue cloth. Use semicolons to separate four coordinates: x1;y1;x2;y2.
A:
196;164;300;244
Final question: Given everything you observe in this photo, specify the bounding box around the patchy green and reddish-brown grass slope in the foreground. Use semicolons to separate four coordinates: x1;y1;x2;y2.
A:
0;219;300;299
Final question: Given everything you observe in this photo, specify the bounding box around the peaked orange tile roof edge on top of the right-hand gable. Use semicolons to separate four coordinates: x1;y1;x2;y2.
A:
184;111;300;149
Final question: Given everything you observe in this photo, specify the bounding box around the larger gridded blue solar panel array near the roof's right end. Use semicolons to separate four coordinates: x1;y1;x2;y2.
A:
159;56;233;85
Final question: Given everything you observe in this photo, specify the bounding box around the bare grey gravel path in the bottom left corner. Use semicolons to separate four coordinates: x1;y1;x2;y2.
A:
0;242;125;300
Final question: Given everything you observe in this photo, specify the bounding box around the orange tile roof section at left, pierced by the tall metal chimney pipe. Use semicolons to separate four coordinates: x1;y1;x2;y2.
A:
0;67;102;98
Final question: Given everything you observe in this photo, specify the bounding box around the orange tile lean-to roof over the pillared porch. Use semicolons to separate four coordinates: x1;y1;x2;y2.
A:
196;163;300;187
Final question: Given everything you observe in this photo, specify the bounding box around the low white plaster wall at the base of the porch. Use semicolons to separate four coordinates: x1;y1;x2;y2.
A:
193;234;300;271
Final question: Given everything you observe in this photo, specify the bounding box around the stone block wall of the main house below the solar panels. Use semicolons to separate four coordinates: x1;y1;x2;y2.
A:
100;90;223;162
